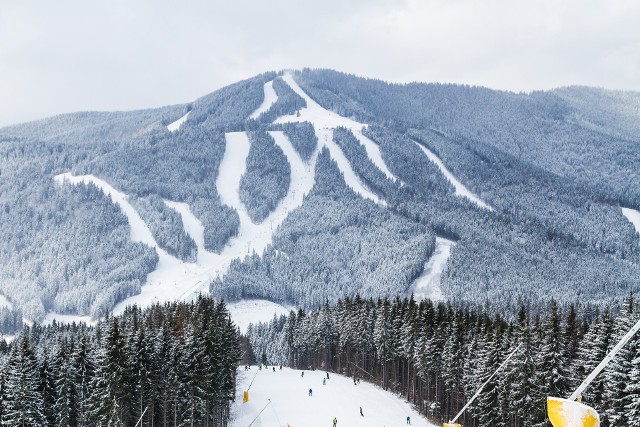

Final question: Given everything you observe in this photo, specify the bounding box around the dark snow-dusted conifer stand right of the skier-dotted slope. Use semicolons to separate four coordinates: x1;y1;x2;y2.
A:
247;295;640;427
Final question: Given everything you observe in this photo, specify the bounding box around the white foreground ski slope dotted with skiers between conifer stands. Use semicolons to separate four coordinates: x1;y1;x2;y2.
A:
229;366;434;427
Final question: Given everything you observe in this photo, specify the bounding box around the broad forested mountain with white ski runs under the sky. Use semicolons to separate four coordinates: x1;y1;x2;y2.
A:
0;70;640;331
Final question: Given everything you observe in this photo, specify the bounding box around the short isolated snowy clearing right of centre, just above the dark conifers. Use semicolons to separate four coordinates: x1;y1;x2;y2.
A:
411;237;456;301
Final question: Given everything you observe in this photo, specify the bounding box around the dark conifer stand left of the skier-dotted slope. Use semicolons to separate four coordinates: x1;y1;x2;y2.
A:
0;297;240;427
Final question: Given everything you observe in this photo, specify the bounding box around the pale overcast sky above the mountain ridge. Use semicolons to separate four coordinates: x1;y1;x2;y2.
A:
0;0;640;126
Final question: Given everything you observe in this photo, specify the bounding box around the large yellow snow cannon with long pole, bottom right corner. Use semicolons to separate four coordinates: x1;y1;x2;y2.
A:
547;314;640;427
